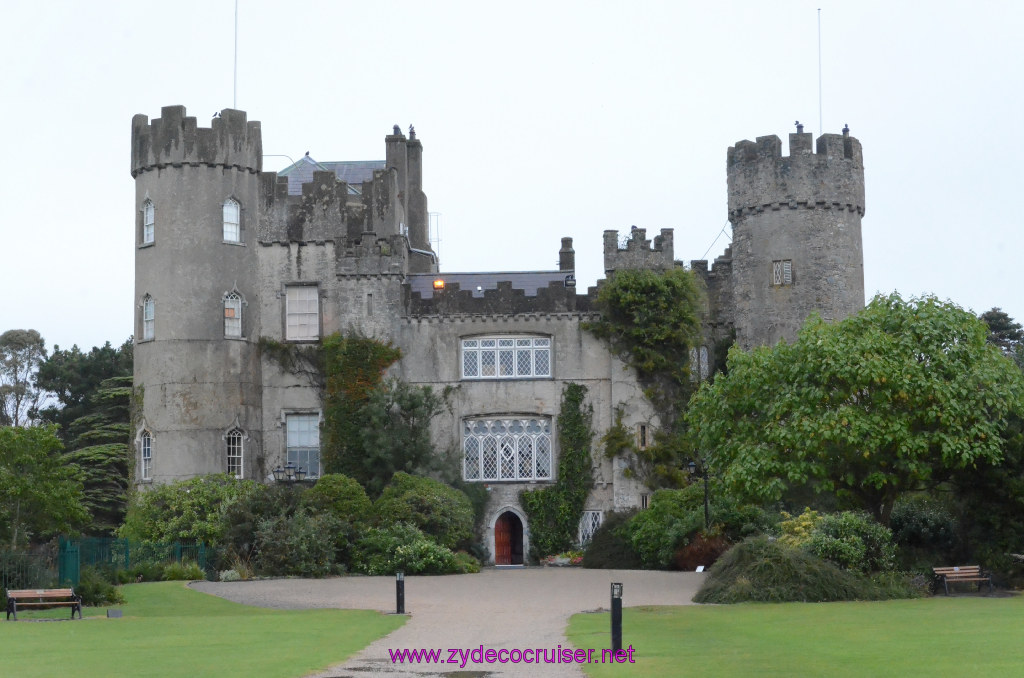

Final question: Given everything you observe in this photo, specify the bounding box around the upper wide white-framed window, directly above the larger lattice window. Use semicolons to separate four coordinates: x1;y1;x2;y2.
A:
459;334;554;381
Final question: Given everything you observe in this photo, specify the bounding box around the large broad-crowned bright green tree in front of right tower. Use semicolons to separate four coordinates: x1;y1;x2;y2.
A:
687;294;1024;524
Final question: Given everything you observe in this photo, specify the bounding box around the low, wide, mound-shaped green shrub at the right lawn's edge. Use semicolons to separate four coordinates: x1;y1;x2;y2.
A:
693;536;873;603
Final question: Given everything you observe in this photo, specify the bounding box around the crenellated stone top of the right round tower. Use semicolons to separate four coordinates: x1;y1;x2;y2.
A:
727;132;864;224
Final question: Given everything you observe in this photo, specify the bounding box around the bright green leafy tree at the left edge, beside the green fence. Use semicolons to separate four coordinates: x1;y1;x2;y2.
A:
0;426;89;549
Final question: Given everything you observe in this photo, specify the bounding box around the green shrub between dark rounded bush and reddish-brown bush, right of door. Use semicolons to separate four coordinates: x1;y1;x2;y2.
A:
629;484;703;569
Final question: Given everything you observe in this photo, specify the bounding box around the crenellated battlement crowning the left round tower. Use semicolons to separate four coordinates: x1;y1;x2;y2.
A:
131;105;263;177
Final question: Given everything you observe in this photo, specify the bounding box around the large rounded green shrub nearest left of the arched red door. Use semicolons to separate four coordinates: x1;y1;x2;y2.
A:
374;471;473;549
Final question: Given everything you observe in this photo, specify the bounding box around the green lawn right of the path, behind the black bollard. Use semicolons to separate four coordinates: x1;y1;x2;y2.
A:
567;596;1024;678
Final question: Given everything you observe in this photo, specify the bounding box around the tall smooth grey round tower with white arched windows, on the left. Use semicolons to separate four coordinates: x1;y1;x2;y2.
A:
131;107;265;483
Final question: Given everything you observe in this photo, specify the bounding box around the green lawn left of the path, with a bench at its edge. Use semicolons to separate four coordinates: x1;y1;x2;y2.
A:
0;582;404;678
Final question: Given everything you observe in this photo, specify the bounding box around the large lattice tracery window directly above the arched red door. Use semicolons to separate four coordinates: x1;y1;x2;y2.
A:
462;417;552;480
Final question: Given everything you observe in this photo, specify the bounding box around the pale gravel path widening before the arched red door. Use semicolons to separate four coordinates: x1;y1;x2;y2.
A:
191;567;705;678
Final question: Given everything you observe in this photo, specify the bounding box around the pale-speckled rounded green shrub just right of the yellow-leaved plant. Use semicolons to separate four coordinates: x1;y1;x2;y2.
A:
805;511;896;573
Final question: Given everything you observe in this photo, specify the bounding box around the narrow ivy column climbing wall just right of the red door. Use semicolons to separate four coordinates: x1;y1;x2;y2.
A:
519;383;594;558
